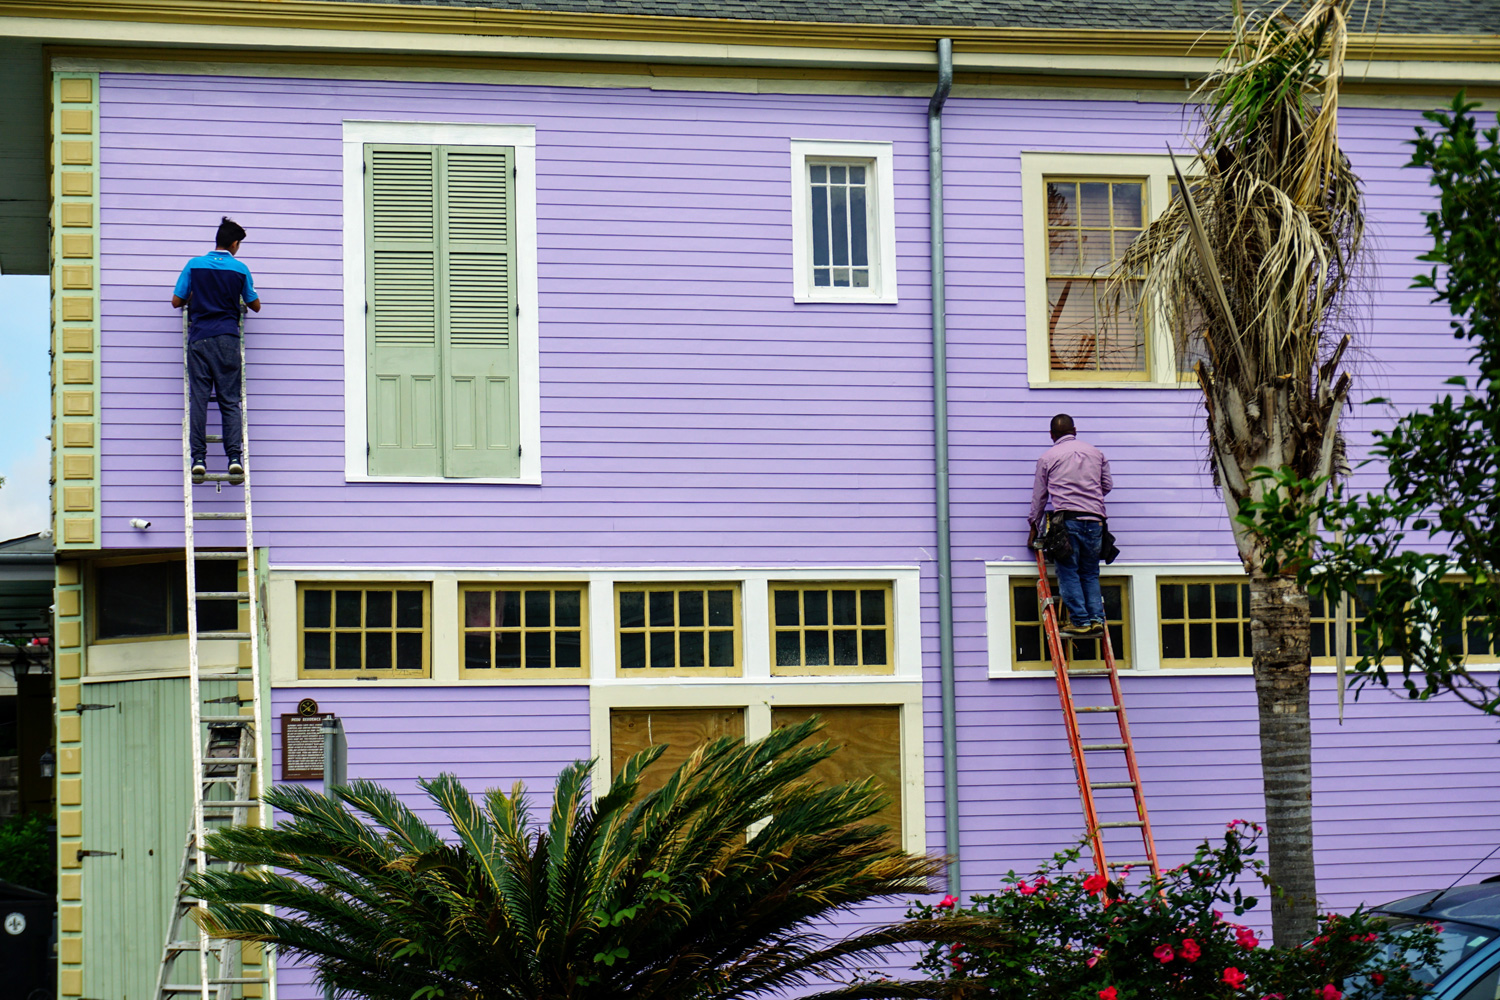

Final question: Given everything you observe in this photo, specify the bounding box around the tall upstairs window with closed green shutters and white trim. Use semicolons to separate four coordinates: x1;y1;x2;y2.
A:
345;121;540;481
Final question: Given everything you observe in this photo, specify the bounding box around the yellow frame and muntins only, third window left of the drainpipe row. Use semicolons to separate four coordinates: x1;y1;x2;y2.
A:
615;580;744;678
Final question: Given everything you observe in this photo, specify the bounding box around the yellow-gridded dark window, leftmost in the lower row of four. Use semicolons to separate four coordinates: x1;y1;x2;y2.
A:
297;583;431;678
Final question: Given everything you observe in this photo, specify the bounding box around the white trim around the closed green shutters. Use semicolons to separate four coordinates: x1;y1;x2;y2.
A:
344;121;542;486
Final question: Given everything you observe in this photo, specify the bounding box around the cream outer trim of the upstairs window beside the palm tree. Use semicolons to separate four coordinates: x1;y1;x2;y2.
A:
1022;150;1197;388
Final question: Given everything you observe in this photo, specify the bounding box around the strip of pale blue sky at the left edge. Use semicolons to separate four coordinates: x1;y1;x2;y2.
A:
0;274;51;541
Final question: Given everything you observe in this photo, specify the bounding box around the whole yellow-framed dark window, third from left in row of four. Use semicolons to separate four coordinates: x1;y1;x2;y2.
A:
615;583;740;676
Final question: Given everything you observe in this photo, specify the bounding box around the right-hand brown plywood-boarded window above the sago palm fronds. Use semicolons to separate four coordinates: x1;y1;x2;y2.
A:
771;705;902;840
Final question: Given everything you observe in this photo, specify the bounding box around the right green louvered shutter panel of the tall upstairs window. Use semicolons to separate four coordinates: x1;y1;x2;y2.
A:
440;147;521;477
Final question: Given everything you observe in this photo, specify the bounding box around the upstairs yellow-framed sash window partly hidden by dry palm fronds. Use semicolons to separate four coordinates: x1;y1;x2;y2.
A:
1044;177;1149;379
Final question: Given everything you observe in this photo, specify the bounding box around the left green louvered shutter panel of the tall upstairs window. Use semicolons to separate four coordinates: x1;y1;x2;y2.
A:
365;145;443;475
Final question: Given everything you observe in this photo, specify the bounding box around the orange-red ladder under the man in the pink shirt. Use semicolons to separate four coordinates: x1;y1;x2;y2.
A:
1037;549;1161;879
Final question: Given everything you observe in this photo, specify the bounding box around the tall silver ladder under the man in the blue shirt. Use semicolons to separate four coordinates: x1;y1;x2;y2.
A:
156;306;273;1000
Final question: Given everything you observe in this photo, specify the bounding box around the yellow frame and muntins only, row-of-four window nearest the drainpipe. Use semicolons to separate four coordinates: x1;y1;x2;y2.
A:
767;580;896;676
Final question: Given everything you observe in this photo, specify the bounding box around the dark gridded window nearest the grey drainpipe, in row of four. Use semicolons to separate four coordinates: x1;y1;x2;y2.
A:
771;583;893;675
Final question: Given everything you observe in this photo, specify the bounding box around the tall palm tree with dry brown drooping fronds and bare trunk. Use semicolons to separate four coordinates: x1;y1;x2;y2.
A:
1116;0;1364;945
